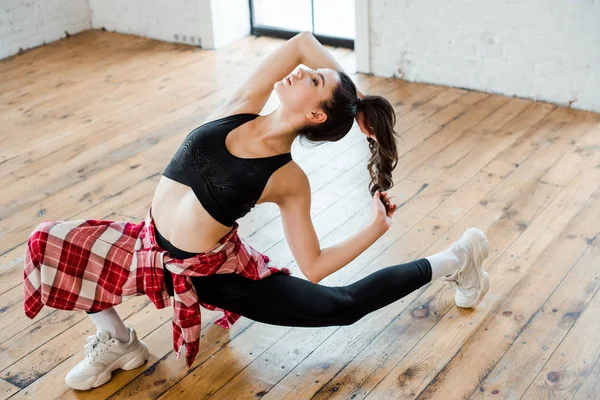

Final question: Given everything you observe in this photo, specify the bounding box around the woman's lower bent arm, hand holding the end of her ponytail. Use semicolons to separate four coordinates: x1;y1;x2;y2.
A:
278;162;396;283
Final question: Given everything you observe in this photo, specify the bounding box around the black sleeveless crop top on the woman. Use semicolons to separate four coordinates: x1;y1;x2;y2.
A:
162;113;292;226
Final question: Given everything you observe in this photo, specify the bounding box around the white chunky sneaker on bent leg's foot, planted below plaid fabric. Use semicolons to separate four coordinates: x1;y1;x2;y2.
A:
65;328;149;390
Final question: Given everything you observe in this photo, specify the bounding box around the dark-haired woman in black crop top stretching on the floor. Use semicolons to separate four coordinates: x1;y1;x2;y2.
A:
25;32;489;390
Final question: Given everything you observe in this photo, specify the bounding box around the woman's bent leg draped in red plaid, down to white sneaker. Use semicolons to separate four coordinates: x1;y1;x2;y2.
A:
24;220;149;390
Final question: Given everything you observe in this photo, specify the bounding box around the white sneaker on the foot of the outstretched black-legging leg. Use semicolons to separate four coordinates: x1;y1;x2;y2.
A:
441;228;490;308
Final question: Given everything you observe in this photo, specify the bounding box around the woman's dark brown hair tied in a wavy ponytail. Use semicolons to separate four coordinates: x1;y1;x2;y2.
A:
298;71;398;195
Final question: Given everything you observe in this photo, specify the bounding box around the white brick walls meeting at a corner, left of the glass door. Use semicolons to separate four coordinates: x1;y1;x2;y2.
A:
0;0;250;59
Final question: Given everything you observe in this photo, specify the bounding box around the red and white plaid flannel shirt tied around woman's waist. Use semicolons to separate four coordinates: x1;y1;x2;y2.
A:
24;209;290;367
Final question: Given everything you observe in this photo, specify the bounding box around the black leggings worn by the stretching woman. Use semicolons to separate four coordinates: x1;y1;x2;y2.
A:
156;227;431;327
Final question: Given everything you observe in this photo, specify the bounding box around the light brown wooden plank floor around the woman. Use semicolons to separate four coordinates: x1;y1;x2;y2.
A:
0;32;600;399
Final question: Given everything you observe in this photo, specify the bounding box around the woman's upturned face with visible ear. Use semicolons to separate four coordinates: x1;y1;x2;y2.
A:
273;68;340;123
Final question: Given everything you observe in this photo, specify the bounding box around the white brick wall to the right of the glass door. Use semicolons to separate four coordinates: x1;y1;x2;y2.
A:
369;0;600;112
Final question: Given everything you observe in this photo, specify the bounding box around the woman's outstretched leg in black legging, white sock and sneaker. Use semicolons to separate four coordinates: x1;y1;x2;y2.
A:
192;229;489;327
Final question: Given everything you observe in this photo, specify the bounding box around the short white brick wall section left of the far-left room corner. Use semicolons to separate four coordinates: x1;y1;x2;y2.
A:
0;0;91;59
